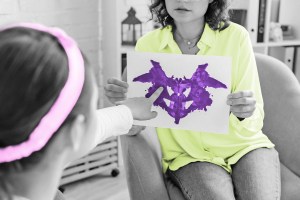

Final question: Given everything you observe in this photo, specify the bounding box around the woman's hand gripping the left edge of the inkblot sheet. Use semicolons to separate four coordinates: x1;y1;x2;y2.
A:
104;78;128;104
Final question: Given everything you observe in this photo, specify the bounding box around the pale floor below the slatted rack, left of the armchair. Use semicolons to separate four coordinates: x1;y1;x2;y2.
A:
63;167;130;200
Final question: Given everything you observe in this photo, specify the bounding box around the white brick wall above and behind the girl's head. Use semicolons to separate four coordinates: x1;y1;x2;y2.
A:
0;0;103;103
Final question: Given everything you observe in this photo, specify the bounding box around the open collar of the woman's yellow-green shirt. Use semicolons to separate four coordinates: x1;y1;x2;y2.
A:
159;23;216;50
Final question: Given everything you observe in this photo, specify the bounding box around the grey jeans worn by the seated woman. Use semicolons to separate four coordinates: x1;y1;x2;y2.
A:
166;148;281;200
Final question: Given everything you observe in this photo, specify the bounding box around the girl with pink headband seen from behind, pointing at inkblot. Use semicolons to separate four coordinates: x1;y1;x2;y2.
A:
0;23;159;200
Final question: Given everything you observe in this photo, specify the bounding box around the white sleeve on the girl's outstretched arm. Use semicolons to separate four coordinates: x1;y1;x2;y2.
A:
94;105;133;146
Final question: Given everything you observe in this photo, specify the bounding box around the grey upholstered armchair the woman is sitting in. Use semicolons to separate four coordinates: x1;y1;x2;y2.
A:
121;54;300;200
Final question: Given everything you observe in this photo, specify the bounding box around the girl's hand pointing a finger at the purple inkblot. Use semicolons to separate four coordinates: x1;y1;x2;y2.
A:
116;87;163;120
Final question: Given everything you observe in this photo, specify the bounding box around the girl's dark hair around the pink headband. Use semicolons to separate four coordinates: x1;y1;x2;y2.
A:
0;27;87;199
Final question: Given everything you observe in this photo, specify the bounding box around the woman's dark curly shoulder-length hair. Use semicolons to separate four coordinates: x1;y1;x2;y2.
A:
149;0;229;31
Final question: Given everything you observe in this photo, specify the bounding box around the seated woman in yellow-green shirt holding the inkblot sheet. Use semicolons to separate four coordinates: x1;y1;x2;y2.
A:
105;0;280;200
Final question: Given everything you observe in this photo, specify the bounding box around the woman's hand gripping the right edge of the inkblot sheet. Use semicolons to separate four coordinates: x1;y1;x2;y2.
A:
227;91;256;119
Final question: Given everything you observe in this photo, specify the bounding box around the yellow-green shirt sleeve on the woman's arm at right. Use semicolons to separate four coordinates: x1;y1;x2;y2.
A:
230;29;264;136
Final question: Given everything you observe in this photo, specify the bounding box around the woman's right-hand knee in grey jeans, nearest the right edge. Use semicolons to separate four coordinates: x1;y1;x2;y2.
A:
232;148;281;200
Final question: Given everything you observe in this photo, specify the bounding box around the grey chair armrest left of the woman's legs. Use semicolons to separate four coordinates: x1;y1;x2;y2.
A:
120;128;169;200
